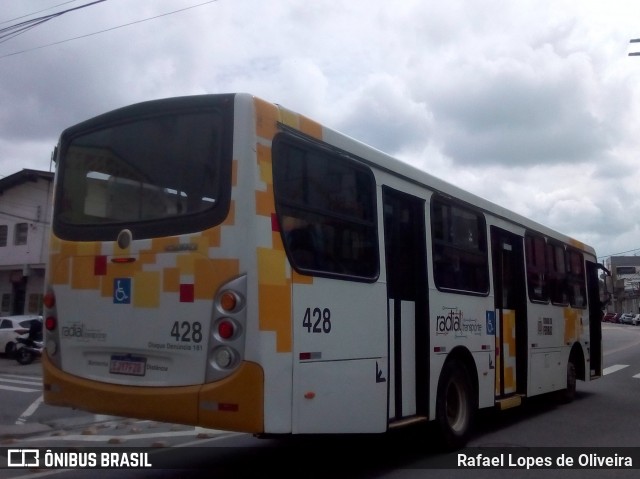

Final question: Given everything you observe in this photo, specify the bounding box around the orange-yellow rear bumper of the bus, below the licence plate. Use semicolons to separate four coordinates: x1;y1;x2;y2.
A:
42;354;264;433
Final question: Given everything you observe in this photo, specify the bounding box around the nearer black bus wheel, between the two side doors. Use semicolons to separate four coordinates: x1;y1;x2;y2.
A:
436;361;476;449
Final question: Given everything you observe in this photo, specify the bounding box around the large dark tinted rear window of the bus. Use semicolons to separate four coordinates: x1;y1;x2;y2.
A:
56;105;231;239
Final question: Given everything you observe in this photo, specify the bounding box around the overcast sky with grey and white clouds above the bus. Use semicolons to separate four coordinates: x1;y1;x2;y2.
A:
0;0;640;257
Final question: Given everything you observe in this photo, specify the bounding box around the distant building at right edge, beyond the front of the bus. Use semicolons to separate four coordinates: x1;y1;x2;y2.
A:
607;256;640;313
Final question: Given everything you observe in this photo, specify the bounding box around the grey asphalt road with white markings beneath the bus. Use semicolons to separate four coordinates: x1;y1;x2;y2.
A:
0;324;640;479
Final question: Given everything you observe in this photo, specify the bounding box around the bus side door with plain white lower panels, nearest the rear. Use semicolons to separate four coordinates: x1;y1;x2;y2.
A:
382;186;429;422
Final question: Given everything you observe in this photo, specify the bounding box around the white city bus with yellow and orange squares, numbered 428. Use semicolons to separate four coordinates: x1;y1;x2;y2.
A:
43;94;602;447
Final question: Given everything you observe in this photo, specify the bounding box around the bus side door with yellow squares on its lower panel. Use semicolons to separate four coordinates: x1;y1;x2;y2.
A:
491;226;528;401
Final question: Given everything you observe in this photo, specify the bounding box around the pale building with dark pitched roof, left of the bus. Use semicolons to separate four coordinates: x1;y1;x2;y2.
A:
0;169;53;315
